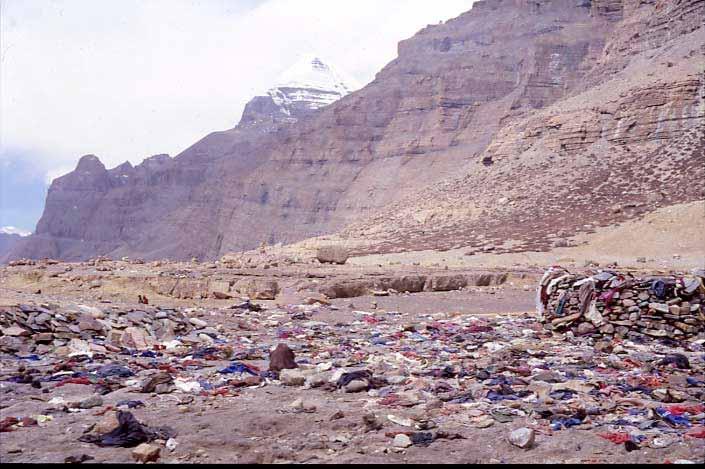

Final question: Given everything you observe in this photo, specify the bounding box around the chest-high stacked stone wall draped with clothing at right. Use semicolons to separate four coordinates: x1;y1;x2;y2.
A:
536;267;705;340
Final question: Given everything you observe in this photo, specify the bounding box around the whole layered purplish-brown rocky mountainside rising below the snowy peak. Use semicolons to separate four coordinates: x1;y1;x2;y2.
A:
15;0;705;259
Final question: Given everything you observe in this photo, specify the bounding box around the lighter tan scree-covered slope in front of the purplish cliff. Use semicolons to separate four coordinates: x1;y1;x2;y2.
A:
340;1;705;253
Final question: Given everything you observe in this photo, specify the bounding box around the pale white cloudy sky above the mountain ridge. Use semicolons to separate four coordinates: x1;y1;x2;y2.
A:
0;0;473;229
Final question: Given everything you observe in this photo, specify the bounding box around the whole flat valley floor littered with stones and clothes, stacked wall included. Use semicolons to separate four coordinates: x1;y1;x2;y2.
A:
0;260;705;463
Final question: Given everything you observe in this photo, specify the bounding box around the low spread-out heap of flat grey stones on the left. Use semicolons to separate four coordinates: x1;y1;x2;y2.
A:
0;304;218;354
